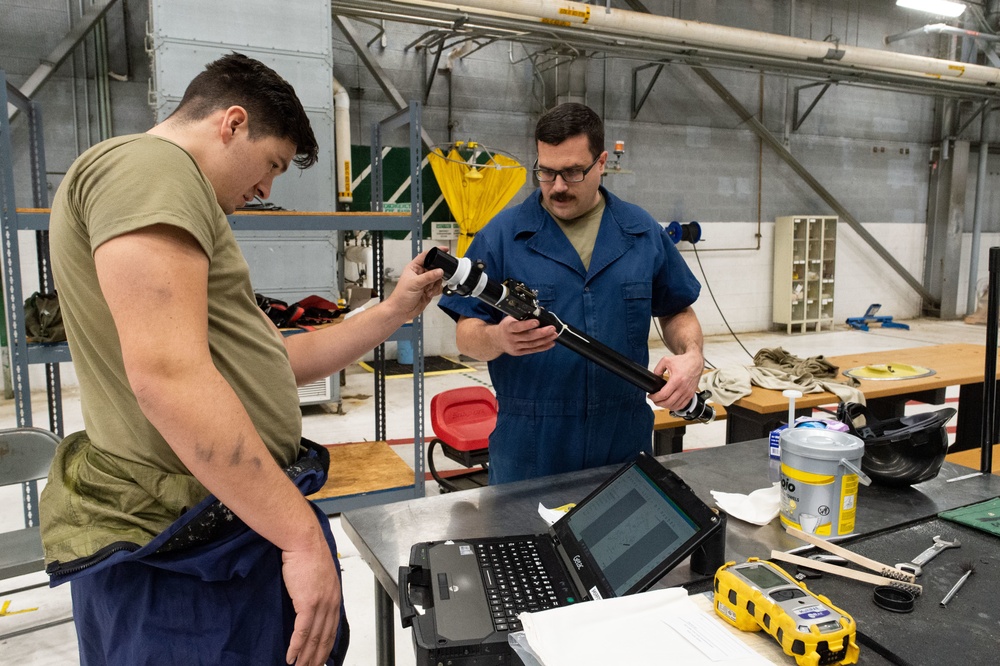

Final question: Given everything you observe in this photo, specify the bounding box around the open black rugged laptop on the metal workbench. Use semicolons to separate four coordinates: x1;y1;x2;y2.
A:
398;454;725;666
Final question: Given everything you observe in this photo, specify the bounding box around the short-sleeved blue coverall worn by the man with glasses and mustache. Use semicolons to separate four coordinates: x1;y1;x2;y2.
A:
439;186;701;483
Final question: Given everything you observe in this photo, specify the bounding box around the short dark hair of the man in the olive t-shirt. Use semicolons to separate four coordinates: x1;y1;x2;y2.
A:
171;53;319;169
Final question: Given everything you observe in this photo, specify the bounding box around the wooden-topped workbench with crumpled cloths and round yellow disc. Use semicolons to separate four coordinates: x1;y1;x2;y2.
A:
726;343;986;451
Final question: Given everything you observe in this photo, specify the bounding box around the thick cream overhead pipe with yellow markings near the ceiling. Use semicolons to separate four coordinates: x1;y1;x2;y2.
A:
394;0;1000;86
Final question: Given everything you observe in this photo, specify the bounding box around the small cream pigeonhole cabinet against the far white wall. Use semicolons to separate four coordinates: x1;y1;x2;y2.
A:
773;215;837;333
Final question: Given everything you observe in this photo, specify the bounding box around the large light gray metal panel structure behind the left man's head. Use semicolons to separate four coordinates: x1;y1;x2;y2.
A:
149;0;340;400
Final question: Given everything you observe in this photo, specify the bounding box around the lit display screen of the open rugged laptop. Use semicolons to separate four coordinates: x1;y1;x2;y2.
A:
565;465;698;596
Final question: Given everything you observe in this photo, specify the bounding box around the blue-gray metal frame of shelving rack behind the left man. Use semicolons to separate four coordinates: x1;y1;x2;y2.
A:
0;70;424;514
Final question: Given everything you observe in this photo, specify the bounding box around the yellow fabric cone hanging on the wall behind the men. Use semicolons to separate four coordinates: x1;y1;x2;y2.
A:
428;141;527;257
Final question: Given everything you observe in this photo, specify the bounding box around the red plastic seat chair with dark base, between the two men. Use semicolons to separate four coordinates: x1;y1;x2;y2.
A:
427;386;497;492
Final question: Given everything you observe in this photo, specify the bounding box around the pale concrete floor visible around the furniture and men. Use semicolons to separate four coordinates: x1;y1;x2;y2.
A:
0;319;986;666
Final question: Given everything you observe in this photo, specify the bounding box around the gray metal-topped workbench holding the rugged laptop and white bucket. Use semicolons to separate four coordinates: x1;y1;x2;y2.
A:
341;441;1000;666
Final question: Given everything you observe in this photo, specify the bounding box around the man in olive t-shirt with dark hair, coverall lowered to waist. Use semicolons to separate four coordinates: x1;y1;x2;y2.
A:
40;53;442;665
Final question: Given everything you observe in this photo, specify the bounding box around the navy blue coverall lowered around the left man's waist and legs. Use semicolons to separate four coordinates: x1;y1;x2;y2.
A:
47;440;350;666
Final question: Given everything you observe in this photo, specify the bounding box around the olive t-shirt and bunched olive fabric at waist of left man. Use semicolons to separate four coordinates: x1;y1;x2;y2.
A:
40;134;302;562
